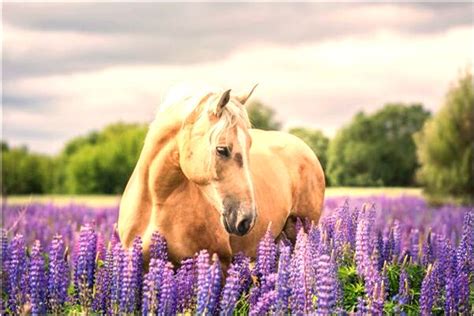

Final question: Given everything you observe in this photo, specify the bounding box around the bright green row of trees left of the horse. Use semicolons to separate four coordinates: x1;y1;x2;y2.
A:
2;123;147;194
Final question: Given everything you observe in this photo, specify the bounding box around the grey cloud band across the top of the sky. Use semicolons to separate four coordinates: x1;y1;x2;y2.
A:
3;3;473;80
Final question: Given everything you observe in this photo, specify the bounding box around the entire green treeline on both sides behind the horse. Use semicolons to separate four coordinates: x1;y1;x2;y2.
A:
2;73;474;201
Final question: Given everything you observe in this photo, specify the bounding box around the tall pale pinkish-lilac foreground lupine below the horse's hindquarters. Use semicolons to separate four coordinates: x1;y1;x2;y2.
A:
289;231;314;314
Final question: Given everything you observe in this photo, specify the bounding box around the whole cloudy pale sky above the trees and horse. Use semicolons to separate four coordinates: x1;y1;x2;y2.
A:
2;3;474;154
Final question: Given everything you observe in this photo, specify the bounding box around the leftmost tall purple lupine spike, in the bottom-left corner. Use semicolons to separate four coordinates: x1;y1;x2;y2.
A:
6;235;28;315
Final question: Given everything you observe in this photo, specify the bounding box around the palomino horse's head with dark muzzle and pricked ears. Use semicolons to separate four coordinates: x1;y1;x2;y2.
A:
179;89;257;236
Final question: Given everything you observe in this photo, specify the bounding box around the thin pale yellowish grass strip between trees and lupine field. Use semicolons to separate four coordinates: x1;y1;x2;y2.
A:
2;187;421;206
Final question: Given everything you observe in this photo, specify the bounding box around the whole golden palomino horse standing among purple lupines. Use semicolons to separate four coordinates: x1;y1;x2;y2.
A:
118;85;325;264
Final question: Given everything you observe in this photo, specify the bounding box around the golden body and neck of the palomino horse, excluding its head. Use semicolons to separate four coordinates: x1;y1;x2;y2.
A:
118;86;325;263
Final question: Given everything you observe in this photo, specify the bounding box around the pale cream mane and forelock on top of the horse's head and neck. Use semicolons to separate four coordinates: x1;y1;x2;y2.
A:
155;85;250;148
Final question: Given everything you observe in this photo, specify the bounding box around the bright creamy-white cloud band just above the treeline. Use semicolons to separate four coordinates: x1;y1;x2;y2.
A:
3;21;474;153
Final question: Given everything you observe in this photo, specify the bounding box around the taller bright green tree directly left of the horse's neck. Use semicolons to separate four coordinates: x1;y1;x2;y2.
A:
60;123;147;194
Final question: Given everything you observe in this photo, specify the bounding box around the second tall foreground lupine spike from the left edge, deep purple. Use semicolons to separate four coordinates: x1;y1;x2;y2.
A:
28;240;47;315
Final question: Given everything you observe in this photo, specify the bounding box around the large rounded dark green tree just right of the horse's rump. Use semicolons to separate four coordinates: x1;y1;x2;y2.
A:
327;104;430;186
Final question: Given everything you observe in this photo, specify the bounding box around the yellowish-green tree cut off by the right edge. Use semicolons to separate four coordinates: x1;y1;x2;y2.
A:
415;72;474;203
